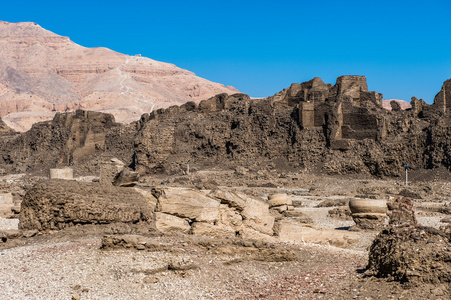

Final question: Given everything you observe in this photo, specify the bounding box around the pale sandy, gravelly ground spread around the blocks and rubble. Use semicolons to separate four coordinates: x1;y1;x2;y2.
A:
0;170;451;299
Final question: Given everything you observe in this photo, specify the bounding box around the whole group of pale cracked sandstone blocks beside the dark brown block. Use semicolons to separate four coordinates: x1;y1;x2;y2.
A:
152;188;274;240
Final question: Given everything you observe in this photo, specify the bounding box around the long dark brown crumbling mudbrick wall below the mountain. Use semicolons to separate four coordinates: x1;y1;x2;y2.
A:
0;76;451;176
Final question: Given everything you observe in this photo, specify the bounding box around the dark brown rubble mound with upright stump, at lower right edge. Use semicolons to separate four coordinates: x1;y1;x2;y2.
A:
368;197;451;289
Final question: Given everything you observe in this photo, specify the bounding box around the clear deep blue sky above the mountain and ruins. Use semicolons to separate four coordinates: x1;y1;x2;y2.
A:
0;0;451;103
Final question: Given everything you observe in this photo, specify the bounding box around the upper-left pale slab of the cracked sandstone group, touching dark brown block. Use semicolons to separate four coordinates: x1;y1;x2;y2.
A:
152;188;220;222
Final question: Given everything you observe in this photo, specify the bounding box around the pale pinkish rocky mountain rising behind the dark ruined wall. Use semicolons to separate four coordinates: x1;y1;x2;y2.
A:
0;21;238;131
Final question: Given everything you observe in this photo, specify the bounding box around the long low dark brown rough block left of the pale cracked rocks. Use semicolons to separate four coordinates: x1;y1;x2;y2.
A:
19;180;153;231
